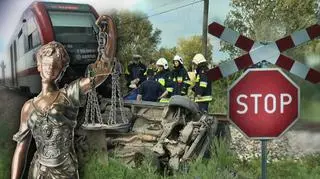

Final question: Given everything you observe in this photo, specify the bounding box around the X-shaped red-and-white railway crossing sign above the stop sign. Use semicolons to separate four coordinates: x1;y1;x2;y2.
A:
207;22;320;83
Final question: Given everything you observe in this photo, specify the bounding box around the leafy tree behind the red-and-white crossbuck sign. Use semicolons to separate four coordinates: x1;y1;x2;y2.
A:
223;0;320;70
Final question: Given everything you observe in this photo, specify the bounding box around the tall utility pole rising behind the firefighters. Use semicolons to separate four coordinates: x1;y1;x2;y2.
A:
202;0;209;60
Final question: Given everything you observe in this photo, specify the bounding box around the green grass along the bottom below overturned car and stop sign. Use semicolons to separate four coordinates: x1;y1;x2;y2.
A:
81;141;320;179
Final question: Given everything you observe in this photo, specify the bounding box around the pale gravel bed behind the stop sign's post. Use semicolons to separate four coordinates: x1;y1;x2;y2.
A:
230;126;320;161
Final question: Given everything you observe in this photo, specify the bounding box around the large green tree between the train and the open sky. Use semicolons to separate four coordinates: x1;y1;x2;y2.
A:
112;10;161;66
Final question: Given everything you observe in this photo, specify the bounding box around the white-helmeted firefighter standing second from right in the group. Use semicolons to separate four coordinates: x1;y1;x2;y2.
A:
171;55;190;96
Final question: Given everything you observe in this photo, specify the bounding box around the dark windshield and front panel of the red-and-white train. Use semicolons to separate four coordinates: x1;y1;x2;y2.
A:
49;11;98;65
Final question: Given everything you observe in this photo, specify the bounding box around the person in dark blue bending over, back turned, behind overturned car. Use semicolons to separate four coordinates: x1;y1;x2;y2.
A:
137;69;168;102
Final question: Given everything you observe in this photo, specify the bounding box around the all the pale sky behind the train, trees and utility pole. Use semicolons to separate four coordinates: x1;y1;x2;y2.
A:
0;0;230;71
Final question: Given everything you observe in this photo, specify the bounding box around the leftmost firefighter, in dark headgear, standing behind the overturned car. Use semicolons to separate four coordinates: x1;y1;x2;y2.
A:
127;54;147;89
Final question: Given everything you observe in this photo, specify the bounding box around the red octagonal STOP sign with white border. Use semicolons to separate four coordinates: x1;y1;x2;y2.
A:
228;69;300;139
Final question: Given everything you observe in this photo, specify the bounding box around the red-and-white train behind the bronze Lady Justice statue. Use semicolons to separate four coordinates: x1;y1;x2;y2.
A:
6;2;98;94
